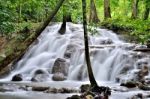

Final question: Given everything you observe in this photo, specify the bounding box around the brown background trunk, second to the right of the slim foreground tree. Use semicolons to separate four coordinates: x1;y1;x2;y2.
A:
104;0;111;19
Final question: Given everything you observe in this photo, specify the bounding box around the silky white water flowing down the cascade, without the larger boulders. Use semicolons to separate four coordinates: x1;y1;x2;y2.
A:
0;23;149;81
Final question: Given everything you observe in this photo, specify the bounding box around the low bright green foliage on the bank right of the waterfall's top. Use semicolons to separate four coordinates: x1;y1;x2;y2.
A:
101;18;150;44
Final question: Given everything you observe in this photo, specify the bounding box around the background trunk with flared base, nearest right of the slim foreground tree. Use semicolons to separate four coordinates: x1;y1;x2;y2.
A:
89;0;100;23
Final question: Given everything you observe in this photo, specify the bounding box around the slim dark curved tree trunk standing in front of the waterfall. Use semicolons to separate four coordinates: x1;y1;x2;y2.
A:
82;0;98;87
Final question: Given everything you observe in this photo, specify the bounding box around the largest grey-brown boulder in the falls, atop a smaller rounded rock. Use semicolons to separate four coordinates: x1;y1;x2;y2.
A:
52;58;69;76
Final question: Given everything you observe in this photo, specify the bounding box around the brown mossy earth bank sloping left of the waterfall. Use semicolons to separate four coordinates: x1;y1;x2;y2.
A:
0;23;39;76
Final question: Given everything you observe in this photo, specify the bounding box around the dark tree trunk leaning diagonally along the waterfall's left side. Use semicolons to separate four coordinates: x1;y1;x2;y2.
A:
0;0;65;74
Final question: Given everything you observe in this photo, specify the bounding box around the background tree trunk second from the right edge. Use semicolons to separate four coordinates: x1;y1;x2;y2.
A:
131;0;139;19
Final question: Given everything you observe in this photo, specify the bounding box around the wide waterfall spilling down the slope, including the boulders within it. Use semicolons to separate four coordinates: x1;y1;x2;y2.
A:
1;23;150;82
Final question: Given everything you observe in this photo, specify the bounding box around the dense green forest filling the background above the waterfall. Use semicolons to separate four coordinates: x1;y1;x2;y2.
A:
0;0;150;43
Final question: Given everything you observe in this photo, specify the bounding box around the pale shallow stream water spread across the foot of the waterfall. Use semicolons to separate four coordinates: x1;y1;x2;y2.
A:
0;81;150;99
